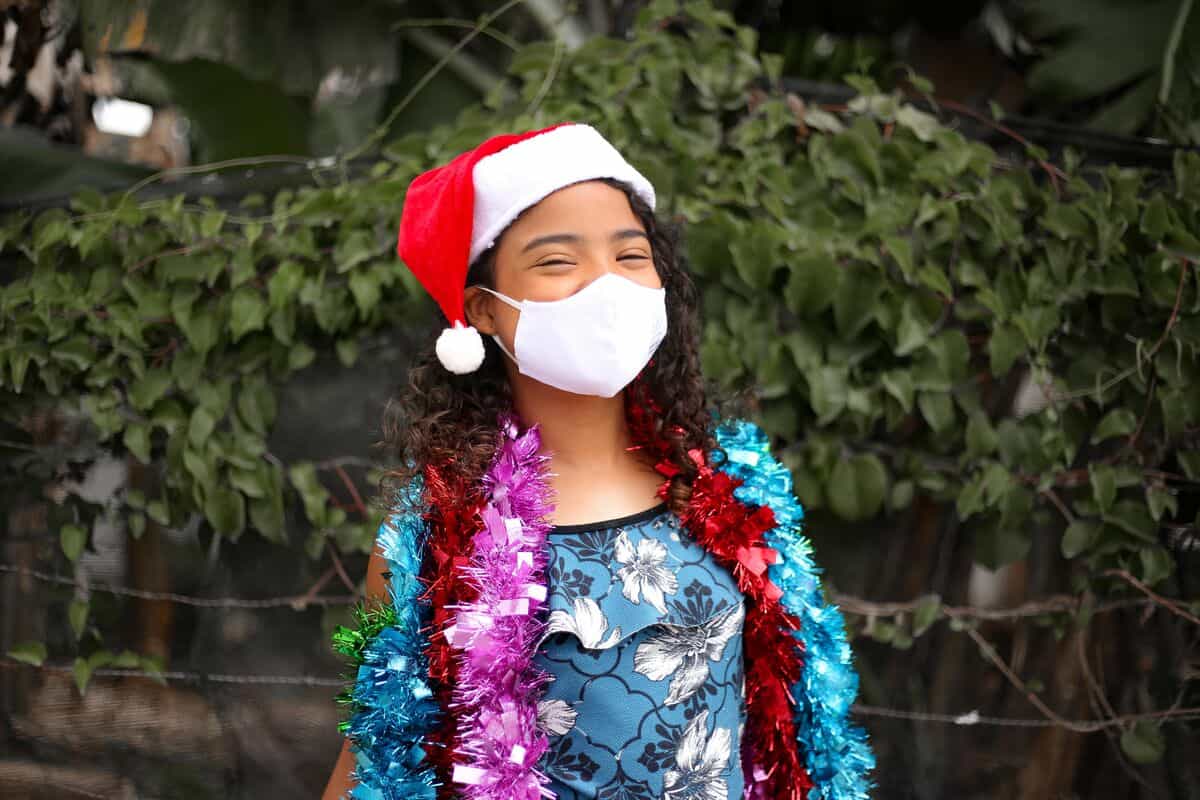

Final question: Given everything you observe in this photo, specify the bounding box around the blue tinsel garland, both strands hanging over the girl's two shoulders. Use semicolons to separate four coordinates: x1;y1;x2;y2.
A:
333;420;875;800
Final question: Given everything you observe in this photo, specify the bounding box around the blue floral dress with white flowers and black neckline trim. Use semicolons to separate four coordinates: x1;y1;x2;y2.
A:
534;504;745;800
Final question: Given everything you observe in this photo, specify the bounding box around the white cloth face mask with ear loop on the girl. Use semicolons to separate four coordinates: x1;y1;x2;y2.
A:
479;272;667;397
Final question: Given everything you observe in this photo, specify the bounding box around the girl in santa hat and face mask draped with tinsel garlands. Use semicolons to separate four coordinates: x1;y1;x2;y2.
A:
324;122;874;800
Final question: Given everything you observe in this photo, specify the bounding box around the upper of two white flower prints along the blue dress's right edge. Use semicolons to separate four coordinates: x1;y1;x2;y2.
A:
634;602;745;705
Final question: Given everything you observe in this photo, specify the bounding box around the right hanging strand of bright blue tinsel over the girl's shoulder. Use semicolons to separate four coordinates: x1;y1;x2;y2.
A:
714;420;875;800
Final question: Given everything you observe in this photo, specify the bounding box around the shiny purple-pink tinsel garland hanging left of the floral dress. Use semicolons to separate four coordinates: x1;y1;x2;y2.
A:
444;415;557;800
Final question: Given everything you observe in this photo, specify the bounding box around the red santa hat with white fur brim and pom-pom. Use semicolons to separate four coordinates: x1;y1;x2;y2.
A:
396;122;654;374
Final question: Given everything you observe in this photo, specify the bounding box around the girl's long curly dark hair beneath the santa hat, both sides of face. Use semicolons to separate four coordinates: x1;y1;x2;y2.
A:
379;178;715;512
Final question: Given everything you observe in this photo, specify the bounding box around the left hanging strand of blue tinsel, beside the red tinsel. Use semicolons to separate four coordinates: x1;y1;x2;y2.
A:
346;480;440;800
